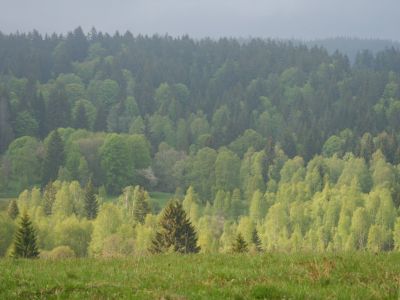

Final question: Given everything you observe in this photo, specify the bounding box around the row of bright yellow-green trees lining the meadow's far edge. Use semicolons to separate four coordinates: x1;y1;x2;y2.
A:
0;157;400;257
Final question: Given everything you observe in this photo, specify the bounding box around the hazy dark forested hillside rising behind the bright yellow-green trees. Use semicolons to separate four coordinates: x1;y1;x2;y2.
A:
0;28;400;193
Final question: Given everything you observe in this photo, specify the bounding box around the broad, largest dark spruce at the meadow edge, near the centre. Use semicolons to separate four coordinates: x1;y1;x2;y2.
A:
150;200;200;253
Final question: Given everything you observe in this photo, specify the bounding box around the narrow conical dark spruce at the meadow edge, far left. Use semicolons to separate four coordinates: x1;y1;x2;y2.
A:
11;212;39;258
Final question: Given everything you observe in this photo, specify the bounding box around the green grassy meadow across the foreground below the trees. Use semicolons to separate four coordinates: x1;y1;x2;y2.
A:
0;253;400;299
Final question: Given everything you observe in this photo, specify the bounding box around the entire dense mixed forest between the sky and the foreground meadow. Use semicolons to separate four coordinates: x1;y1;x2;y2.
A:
0;28;400;256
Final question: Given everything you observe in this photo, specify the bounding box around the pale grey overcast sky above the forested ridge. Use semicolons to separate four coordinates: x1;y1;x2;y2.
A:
0;0;400;40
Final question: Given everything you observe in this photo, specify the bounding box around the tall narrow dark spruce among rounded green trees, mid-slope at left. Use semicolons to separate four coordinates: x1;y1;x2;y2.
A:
42;130;65;186
